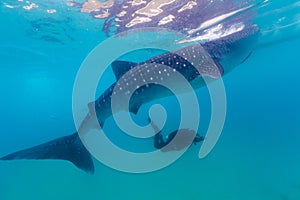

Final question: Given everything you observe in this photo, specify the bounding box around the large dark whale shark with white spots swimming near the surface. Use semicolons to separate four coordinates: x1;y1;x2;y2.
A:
0;0;259;174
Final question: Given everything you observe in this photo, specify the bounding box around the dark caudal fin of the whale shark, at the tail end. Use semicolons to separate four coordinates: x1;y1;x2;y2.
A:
0;133;95;174
